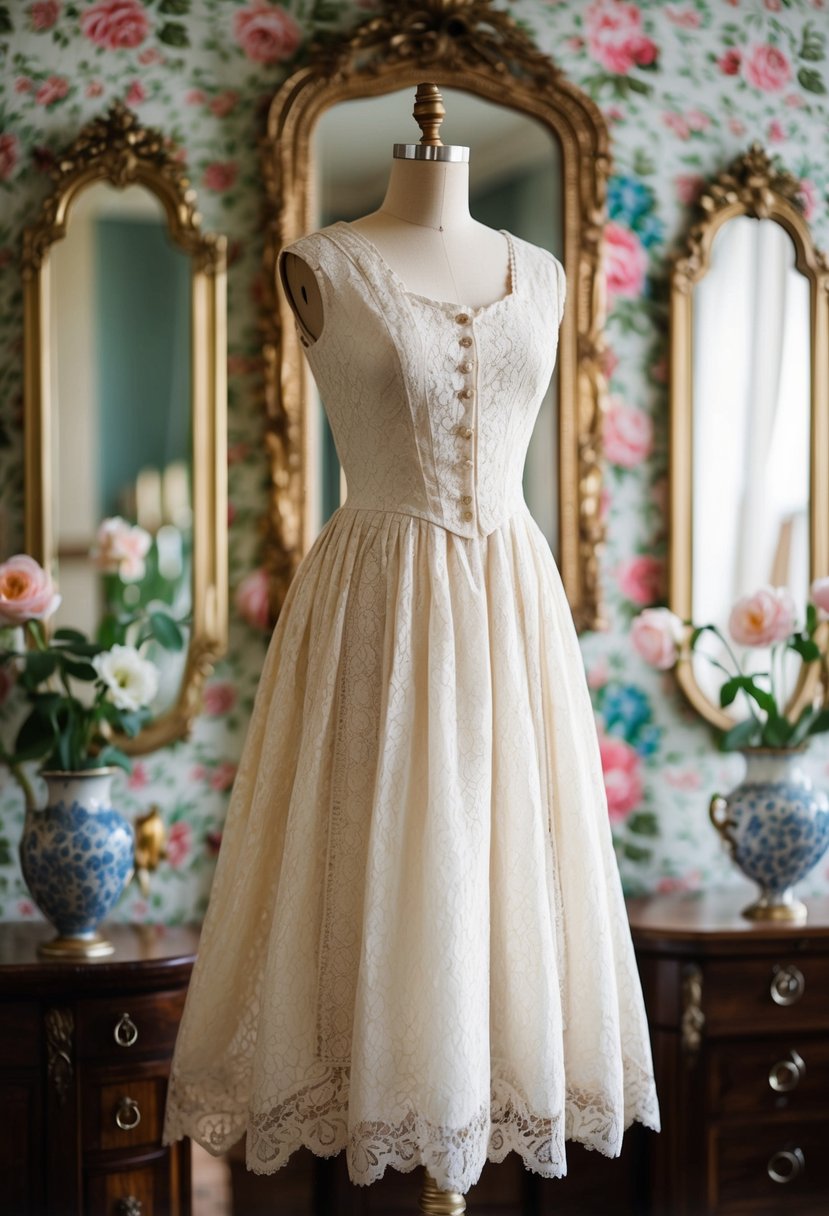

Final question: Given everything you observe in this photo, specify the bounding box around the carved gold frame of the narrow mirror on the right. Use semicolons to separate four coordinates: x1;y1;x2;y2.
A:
669;143;829;731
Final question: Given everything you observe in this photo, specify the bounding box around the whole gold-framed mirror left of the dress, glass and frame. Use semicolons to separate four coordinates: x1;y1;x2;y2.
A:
23;103;227;753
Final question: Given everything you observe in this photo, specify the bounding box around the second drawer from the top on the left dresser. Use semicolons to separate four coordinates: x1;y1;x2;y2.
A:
83;1075;167;1153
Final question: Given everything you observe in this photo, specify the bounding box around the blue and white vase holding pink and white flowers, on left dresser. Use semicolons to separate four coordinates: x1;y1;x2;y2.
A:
21;769;135;958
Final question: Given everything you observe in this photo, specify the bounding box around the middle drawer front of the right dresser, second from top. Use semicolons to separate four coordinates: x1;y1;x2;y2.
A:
709;1034;829;1118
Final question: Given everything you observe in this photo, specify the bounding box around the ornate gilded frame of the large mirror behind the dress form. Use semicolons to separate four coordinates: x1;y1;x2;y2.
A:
263;0;609;629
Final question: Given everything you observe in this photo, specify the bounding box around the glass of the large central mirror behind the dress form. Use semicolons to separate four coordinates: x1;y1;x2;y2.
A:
308;88;564;556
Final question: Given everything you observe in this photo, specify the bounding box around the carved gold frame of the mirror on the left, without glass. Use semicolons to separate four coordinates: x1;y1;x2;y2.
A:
22;102;227;755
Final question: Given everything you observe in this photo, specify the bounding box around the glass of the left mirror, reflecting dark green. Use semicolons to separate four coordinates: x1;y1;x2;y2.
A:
49;182;192;713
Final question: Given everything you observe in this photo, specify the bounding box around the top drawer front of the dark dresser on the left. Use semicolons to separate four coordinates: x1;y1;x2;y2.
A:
77;989;185;1064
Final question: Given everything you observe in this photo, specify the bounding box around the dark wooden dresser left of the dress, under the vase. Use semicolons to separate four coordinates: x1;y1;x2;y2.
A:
0;924;198;1216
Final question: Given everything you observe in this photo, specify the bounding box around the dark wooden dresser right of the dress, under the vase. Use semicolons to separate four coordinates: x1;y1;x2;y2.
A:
628;893;829;1216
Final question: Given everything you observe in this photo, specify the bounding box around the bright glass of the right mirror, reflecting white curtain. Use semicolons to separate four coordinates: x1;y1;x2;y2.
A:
692;215;812;717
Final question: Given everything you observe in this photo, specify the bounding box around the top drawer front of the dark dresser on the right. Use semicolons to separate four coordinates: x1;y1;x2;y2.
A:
703;951;829;1035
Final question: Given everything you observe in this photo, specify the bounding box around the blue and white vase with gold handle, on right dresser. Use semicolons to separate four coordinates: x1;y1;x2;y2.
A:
709;748;829;923
